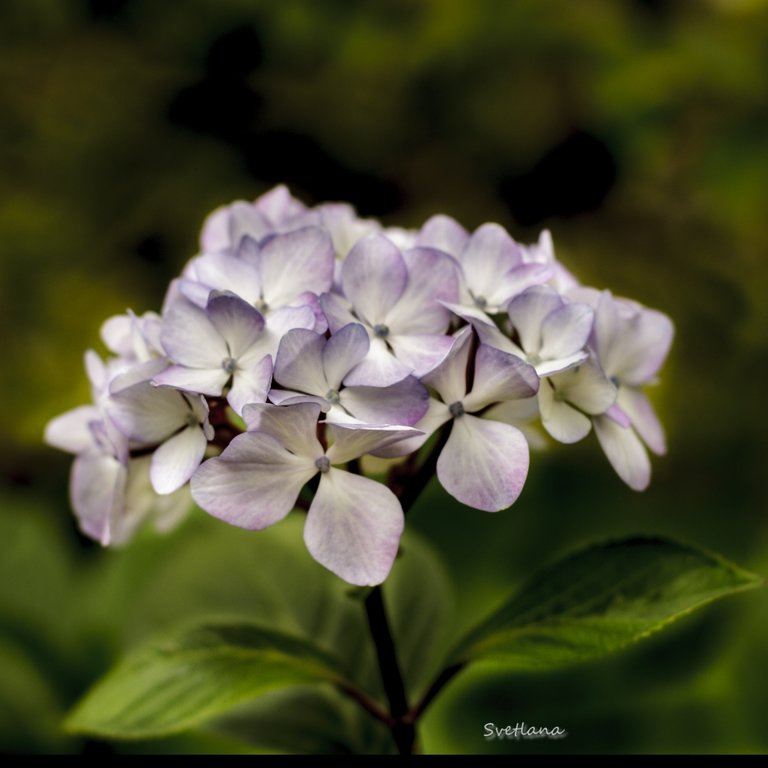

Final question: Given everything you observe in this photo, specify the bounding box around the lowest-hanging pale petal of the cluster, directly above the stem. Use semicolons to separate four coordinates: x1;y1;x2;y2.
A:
304;468;404;586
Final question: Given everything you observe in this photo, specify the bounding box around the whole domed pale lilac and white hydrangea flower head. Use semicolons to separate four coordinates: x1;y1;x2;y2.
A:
46;186;673;585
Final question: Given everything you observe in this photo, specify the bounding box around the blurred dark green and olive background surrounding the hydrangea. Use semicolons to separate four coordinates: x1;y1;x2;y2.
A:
0;0;768;754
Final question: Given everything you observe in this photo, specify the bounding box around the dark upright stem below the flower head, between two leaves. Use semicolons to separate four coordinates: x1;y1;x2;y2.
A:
365;586;416;755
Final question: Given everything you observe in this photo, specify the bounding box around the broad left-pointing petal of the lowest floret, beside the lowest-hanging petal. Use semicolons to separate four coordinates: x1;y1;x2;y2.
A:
190;432;317;530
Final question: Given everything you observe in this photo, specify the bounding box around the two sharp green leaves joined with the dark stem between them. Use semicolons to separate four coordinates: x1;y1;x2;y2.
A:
67;538;762;752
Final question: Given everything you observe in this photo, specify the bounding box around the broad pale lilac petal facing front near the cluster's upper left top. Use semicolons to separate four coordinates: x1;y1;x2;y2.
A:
260;227;336;307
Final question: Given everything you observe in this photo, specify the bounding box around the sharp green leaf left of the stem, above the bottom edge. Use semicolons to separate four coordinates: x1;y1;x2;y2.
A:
66;622;352;739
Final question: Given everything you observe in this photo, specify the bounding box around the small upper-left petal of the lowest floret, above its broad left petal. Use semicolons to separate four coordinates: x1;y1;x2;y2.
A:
242;403;324;461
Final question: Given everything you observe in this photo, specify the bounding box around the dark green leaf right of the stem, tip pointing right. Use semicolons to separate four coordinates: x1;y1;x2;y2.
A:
449;538;762;671
